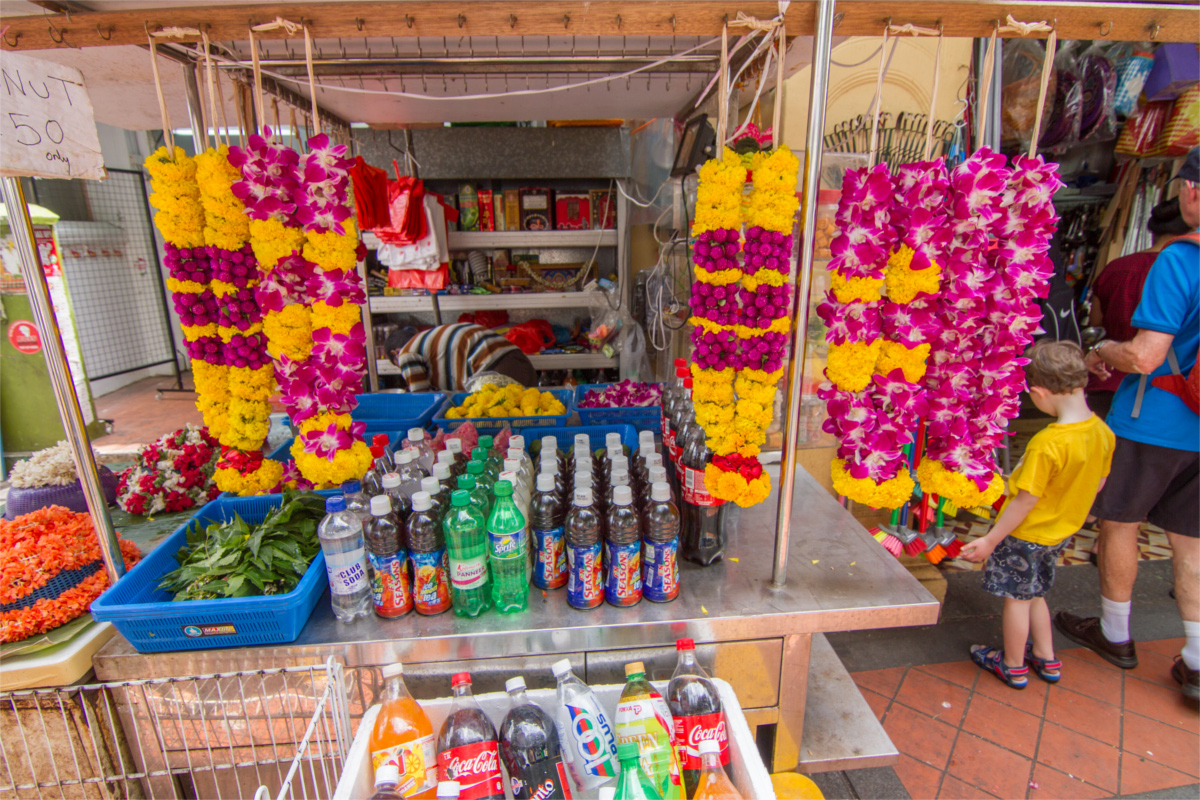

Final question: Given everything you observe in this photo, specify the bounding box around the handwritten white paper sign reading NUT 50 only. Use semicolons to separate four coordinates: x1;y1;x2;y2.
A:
0;50;108;180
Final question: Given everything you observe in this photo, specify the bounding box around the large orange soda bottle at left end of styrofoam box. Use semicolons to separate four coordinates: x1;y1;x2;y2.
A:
371;663;438;799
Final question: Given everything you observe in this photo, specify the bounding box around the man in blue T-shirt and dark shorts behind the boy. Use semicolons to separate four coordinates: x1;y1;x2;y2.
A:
1055;148;1200;698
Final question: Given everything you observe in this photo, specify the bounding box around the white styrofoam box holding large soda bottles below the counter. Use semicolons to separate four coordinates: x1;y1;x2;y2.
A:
334;678;775;800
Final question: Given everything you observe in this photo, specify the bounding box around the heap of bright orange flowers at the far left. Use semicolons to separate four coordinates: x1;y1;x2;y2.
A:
0;506;142;642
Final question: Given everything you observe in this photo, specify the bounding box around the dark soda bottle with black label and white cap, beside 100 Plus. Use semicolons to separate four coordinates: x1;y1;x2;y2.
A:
500;678;571;800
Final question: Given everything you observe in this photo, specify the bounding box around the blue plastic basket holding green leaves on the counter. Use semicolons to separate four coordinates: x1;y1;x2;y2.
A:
91;494;329;652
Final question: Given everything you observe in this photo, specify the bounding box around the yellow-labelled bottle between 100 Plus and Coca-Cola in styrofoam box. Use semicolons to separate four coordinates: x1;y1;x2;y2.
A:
617;661;683;800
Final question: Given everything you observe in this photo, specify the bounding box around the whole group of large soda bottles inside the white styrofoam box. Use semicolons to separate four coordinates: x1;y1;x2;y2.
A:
370;639;742;800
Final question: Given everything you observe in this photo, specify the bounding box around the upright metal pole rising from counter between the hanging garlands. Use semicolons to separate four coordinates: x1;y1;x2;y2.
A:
770;0;834;589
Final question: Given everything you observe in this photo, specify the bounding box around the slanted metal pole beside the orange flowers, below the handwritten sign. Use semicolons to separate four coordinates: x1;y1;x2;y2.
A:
2;178;125;584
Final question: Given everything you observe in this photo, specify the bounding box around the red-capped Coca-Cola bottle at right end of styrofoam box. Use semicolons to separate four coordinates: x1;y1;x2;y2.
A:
667;639;732;798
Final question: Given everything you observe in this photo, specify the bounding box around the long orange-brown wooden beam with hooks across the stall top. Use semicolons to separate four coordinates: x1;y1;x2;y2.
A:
0;0;1200;50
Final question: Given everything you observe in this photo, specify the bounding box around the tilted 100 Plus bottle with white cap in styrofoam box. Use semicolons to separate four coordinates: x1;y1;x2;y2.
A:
550;658;620;794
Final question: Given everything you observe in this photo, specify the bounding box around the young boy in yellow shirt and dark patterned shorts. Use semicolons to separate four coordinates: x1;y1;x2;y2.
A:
960;342;1116;688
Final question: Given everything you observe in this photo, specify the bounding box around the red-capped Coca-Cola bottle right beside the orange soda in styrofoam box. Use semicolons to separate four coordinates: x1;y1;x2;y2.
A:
438;672;504;800
